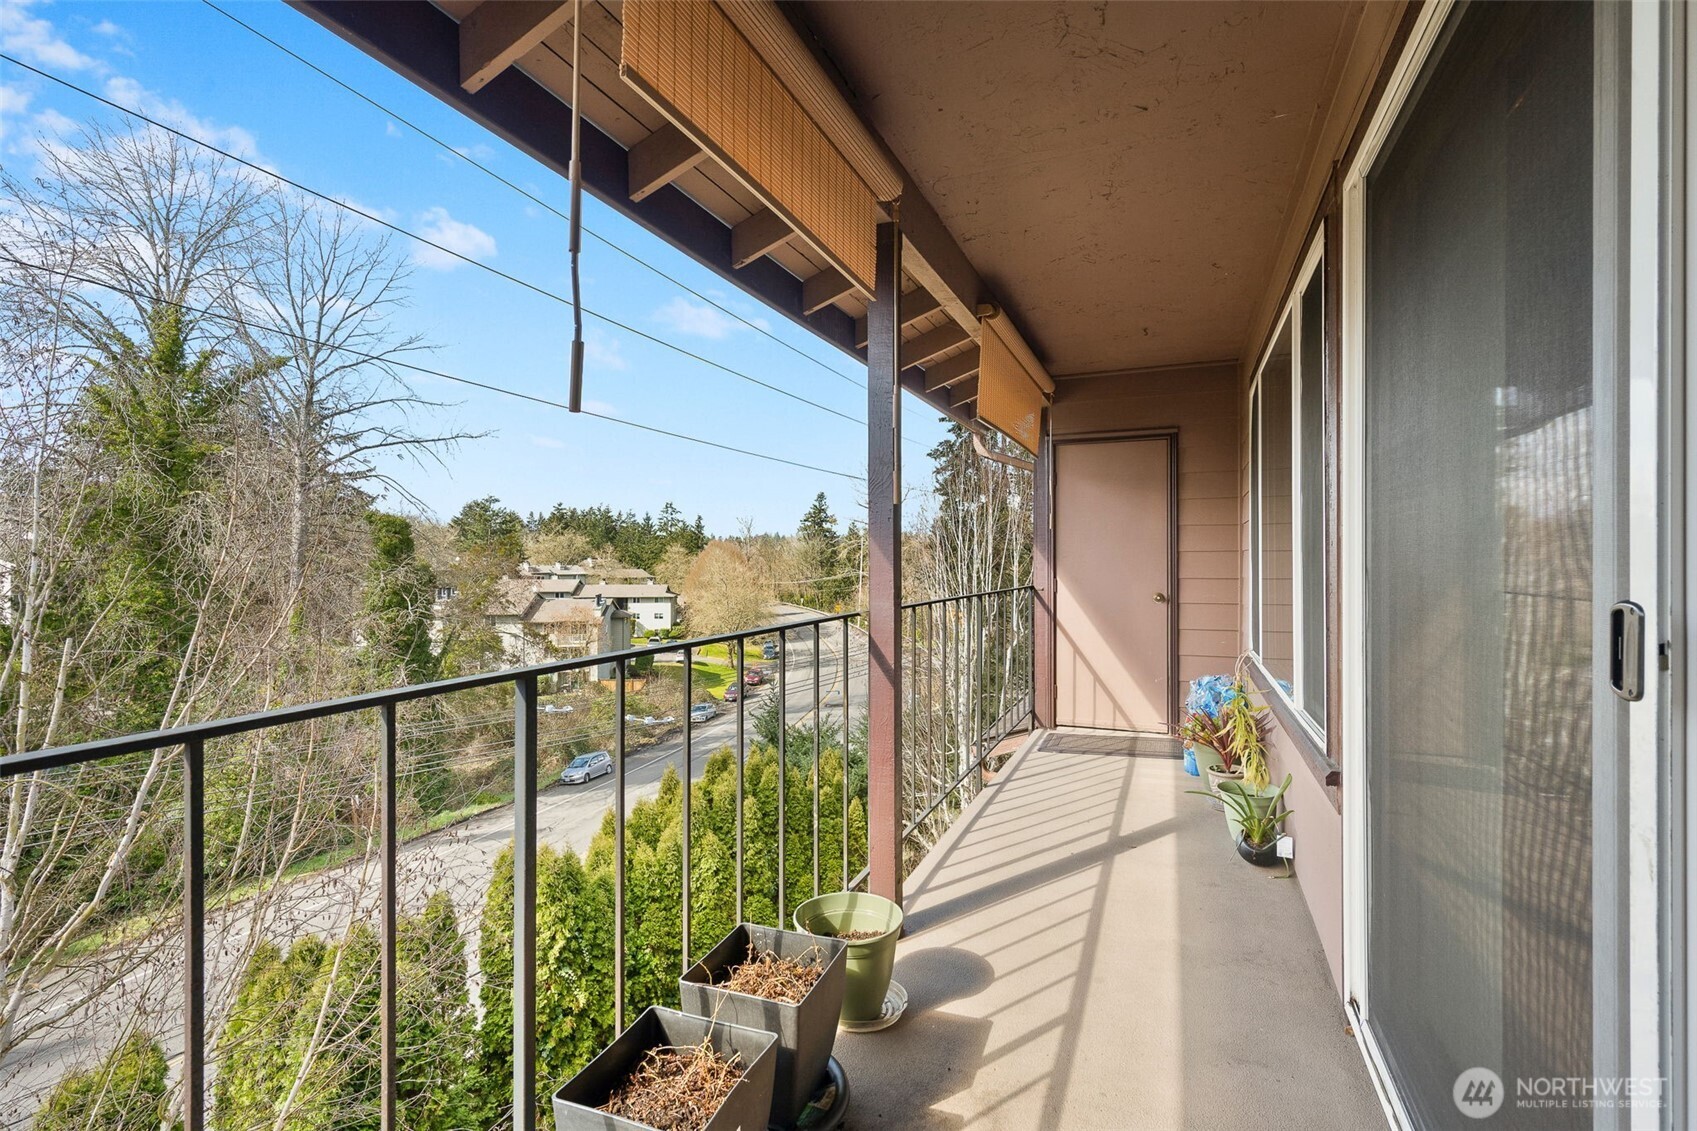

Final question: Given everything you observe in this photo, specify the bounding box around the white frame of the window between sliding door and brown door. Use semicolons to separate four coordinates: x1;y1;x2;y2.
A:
1246;229;1330;751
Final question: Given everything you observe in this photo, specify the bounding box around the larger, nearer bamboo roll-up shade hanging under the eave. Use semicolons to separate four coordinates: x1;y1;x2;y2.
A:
619;0;877;297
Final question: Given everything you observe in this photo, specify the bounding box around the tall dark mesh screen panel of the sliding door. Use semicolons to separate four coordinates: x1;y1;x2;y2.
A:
1363;3;1593;1131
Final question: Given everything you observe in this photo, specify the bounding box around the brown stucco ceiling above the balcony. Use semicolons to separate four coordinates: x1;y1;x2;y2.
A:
799;0;1354;374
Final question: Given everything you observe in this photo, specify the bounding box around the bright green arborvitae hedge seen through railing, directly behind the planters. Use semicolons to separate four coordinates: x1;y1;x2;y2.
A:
477;732;867;1126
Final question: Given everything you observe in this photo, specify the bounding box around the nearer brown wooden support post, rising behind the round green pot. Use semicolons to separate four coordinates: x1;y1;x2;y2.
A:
865;222;903;903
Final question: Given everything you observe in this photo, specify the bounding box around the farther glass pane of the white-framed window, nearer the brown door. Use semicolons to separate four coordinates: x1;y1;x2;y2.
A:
1259;323;1297;683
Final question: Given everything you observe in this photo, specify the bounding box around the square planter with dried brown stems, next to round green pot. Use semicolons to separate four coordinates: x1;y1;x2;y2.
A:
677;922;849;1128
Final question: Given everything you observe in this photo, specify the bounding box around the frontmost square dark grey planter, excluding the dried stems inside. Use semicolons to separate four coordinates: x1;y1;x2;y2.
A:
553;1005;777;1131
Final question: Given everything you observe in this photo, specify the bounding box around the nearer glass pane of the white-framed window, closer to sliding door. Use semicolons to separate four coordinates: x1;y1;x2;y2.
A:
1297;270;1325;727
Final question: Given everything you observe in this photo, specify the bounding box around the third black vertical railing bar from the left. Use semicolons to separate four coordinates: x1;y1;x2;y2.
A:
512;676;536;1131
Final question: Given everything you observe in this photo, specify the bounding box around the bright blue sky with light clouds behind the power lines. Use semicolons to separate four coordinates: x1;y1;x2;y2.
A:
0;0;944;533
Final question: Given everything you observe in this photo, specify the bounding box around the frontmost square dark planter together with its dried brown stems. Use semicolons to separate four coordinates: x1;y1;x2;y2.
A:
553;1005;777;1131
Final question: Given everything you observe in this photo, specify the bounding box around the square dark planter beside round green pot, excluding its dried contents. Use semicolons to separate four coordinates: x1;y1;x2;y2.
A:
677;922;849;1128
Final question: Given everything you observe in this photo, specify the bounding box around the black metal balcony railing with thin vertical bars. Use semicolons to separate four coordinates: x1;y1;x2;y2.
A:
0;588;1033;1131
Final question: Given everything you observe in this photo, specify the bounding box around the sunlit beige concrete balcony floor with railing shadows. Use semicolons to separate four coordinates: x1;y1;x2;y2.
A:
837;732;1385;1131
